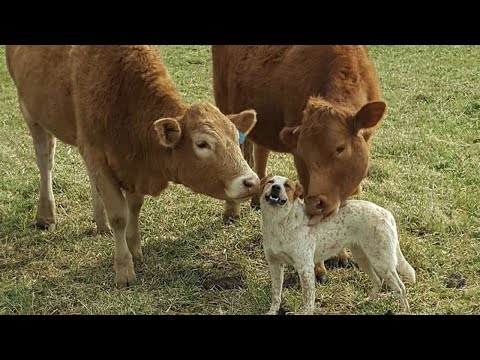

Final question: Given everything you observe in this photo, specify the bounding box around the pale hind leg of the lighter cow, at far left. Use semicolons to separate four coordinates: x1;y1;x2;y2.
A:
21;106;56;230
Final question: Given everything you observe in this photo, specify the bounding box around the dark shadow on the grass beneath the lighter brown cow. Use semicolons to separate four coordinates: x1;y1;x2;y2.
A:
54;219;249;291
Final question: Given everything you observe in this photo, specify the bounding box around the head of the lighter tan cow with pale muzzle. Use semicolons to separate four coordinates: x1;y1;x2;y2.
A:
154;103;260;201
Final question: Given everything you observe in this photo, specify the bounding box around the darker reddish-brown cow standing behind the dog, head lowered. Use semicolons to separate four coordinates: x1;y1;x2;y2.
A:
212;45;386;280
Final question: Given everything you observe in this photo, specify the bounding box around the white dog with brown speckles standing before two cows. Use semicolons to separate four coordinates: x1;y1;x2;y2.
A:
260;176;415;314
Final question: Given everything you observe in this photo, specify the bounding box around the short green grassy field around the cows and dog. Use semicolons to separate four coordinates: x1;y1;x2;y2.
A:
0;46;480;314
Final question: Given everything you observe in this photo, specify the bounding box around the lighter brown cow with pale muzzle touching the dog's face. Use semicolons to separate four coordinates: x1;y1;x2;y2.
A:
6;46;260;287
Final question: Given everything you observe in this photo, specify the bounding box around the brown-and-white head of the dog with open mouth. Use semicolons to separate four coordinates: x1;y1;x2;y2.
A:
260;176;303;207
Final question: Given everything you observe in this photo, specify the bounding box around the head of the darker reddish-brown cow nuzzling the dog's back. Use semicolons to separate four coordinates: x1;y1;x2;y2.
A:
280;97;386;216
